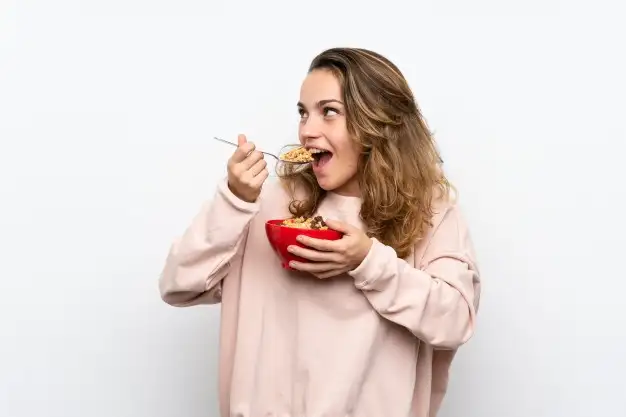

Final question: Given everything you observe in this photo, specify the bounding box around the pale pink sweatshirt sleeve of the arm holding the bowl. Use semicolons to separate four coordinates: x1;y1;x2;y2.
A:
350;202;480;349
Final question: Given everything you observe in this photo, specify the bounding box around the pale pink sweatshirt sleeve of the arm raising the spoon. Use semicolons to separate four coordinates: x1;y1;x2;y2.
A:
159;180;259;307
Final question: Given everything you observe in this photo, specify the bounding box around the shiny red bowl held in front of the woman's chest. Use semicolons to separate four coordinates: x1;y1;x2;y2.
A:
265;220;343;270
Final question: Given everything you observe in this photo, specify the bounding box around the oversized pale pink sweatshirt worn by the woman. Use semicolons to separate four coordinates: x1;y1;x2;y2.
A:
159;181;480;417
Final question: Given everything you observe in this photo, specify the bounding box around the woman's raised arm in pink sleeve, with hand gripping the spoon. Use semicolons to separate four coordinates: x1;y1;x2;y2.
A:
159;135;269;307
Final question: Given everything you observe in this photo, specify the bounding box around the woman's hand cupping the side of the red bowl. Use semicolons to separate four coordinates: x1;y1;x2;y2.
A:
288;220;372;279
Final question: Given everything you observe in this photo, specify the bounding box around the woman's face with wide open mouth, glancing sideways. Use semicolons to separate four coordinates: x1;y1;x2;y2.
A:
298;69;360;196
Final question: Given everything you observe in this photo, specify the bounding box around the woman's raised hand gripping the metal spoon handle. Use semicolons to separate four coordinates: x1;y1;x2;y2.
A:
228;135;269;203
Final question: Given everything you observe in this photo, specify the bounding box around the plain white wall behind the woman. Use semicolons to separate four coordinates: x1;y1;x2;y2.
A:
0;0;626;417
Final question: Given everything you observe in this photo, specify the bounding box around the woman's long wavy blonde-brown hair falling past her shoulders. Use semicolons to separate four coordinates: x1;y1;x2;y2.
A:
277;48;451;258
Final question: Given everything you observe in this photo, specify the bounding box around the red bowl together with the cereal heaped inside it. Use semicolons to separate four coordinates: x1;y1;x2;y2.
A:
265;216;343;269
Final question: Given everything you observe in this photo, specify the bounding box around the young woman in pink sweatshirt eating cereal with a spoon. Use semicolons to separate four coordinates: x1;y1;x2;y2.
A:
160;48;480;417
